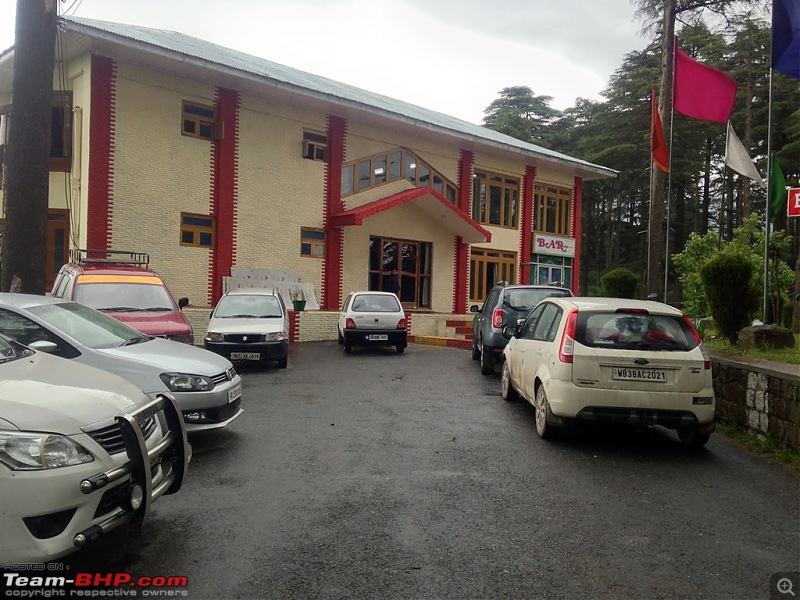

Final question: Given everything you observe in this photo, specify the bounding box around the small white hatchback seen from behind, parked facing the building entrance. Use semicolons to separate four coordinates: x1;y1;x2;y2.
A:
337;291;408;354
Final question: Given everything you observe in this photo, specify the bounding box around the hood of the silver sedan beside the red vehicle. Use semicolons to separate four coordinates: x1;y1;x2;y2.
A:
97;338;233;376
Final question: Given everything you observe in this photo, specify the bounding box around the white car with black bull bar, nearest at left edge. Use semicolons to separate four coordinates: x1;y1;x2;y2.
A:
0;336;190;566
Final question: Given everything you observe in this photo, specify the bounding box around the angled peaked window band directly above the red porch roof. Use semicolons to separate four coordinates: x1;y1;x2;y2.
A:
342;149;458;204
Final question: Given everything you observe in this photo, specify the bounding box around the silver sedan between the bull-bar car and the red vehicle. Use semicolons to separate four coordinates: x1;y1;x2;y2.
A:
0;293;242;433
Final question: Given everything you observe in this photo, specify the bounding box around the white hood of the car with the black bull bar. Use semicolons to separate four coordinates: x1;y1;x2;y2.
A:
0;352;147;435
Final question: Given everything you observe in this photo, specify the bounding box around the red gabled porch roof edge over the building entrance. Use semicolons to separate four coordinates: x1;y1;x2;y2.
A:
330;187;492;244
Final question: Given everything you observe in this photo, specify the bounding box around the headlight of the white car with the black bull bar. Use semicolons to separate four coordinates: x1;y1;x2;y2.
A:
0;431;94;471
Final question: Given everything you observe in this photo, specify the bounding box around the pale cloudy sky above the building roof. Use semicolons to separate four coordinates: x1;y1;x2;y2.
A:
0;0;647;123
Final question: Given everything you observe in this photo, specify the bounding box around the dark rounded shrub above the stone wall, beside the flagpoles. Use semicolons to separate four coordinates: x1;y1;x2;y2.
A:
700;250;758;345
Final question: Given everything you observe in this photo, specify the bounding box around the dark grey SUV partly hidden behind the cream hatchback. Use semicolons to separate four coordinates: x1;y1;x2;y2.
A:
469;282;573;375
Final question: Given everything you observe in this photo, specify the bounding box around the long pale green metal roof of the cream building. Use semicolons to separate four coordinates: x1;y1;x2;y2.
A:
61;17;617;179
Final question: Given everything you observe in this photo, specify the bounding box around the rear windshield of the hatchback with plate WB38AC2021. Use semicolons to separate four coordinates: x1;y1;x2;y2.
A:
575;311;697;351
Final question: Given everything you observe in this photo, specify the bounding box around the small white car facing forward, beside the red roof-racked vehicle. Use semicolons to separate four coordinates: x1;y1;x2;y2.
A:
204;288;289;369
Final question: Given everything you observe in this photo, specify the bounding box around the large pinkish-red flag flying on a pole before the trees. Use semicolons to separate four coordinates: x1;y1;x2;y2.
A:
673;44;736;123
